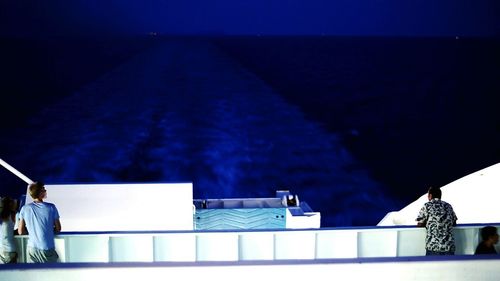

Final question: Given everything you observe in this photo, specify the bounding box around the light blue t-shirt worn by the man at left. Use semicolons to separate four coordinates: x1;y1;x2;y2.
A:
19;202;59;250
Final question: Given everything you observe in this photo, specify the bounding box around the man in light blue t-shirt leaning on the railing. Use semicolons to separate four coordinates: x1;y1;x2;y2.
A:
18;182;61;263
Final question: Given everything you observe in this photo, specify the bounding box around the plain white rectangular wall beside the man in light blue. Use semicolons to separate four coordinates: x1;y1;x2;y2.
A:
26;183;193;232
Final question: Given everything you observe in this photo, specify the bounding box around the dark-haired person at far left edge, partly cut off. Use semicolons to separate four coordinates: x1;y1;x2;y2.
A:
0;197;17;263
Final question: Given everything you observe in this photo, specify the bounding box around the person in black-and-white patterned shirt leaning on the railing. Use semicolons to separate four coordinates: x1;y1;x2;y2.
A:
416;187;457;256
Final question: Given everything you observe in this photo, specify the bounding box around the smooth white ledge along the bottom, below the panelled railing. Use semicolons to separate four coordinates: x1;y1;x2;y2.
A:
0;255;500;281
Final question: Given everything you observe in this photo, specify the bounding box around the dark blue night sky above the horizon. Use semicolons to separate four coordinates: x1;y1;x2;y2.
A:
0;0;500;37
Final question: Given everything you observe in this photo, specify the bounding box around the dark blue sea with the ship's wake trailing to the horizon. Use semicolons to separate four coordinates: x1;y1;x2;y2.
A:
0;37;500;226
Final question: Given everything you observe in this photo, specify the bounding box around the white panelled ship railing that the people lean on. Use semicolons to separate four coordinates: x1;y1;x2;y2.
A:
16;224;500;262
